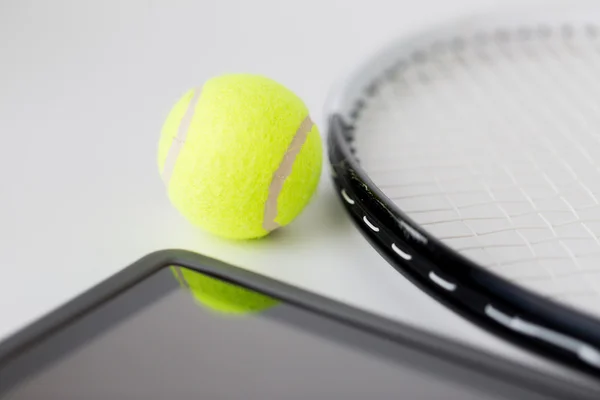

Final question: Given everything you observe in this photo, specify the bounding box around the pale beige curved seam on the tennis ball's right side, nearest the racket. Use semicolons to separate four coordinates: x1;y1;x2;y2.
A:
263;116;314;232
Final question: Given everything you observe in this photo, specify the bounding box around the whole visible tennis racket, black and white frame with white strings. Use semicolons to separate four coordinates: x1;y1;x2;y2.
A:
328;11;600;376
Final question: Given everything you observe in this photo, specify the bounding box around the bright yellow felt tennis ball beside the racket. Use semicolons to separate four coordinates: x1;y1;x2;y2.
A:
158;74;322;239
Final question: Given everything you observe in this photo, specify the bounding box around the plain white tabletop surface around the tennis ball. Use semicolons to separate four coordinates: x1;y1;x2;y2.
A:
0;0;592;384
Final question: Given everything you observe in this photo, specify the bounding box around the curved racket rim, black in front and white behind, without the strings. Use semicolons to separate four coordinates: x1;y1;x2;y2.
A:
327;9;600;373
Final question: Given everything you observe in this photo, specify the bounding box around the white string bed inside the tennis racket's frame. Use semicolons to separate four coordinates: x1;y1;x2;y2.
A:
356;27;600;316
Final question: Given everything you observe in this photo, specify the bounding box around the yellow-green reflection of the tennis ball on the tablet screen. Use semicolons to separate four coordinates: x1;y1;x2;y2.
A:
171;267;277;314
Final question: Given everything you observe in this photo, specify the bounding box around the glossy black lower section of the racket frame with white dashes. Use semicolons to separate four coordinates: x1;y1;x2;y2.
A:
327;114;600;378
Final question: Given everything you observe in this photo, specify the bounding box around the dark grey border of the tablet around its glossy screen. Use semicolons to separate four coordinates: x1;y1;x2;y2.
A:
0;250;599;399
